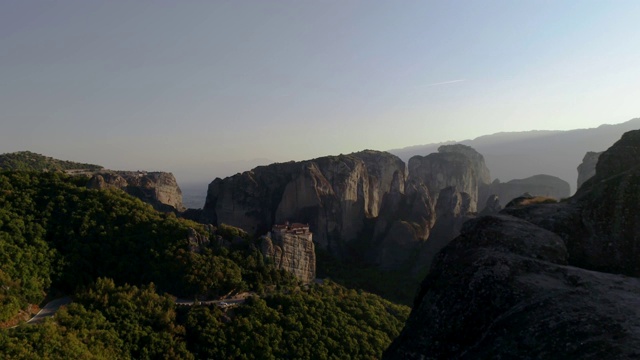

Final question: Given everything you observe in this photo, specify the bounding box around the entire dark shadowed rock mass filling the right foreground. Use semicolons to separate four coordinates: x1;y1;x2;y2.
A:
384;131;640;359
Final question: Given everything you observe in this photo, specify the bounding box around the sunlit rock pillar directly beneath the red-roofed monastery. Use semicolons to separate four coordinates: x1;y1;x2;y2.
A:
261;223;316;283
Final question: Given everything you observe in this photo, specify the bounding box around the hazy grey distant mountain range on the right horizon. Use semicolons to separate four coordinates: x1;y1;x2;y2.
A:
388;118;640;192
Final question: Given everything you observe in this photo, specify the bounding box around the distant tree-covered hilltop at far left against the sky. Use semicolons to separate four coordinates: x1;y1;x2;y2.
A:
0;151;102;171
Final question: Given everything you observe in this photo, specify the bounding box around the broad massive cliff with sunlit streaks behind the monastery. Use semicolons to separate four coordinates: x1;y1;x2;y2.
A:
202;150;406;255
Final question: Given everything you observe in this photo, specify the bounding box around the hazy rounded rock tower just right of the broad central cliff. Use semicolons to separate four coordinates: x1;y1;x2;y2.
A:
409;145;490;212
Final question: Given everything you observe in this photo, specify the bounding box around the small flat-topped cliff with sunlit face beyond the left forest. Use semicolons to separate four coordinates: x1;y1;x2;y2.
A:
87;170;185;212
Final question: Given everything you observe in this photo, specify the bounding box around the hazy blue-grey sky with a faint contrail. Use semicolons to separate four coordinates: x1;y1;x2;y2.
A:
0;0;640;183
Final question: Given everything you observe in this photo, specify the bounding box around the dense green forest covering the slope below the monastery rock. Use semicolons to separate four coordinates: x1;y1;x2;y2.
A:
0;171;409;359
